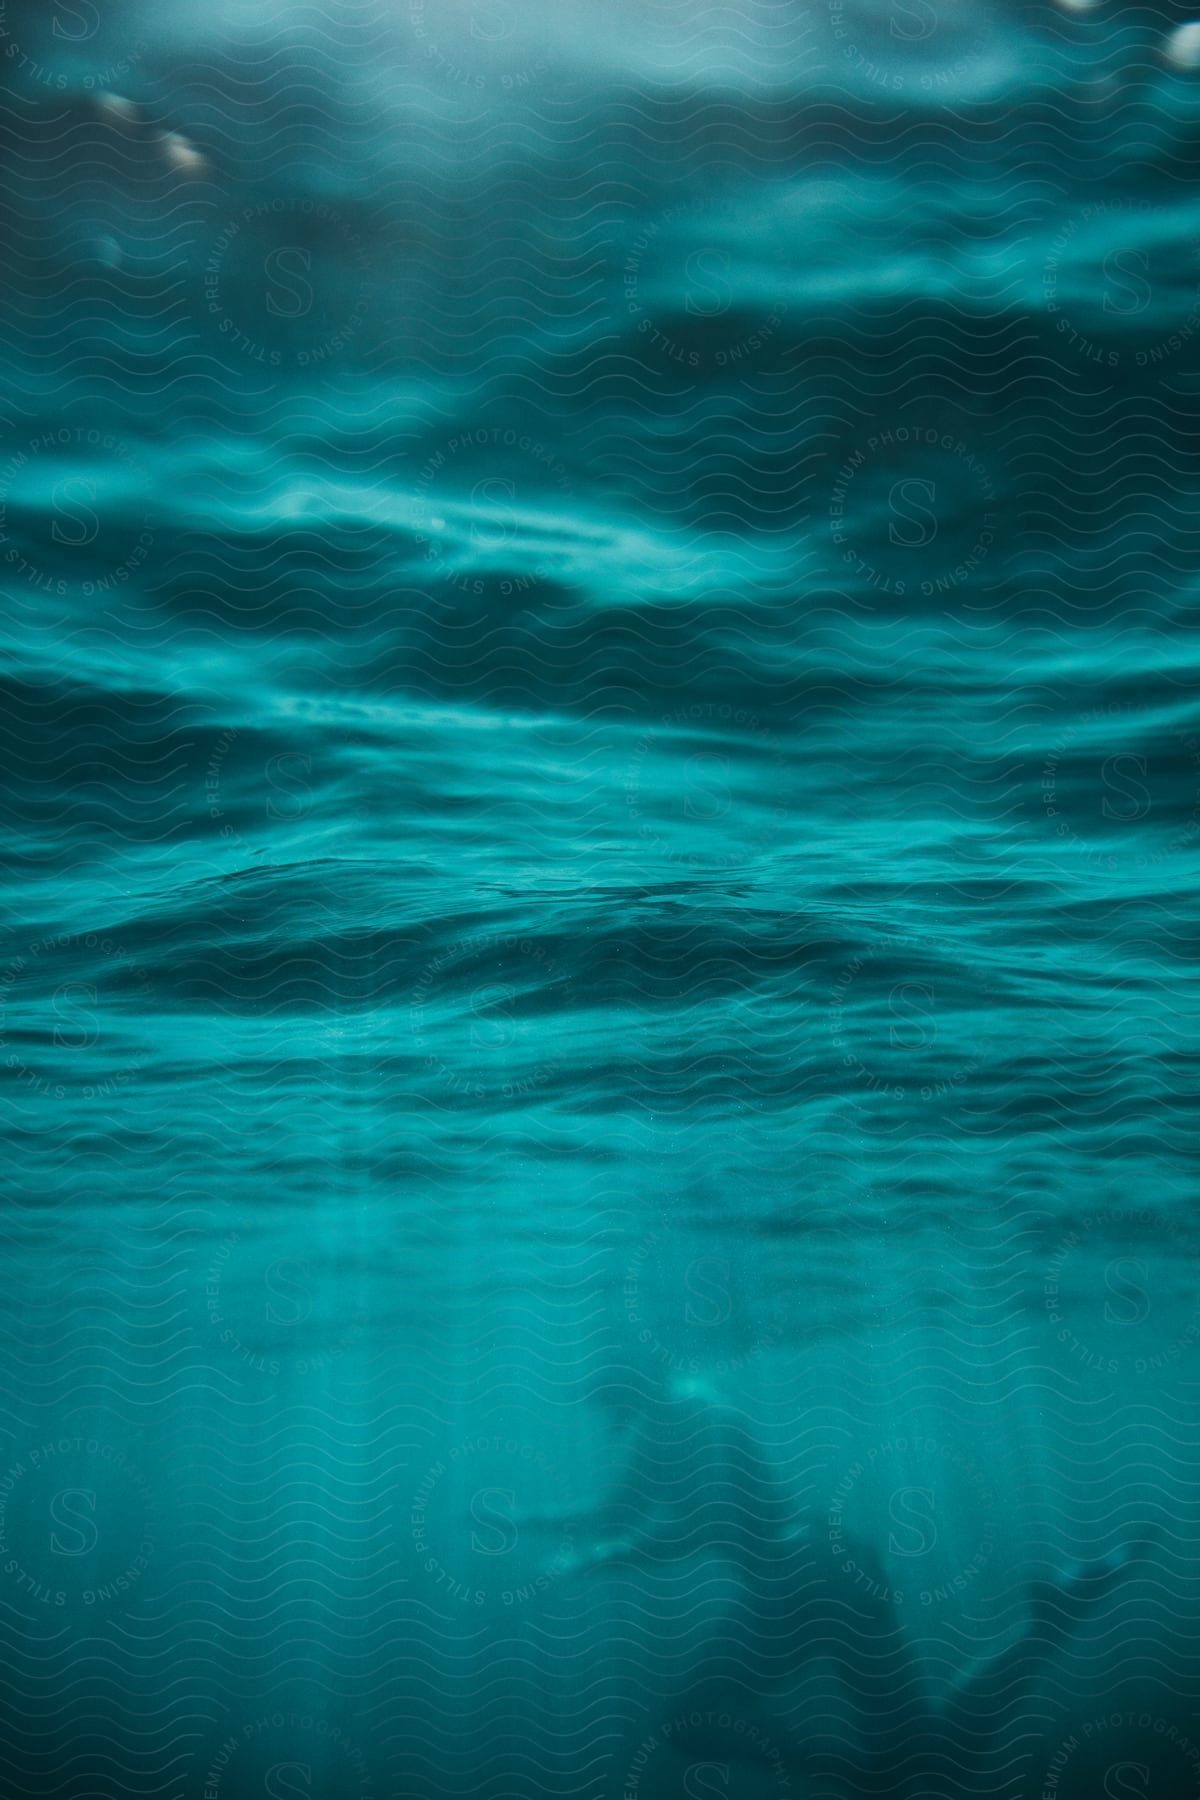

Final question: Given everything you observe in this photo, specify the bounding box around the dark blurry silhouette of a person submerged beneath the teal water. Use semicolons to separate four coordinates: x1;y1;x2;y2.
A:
574;1379;1148;1800
